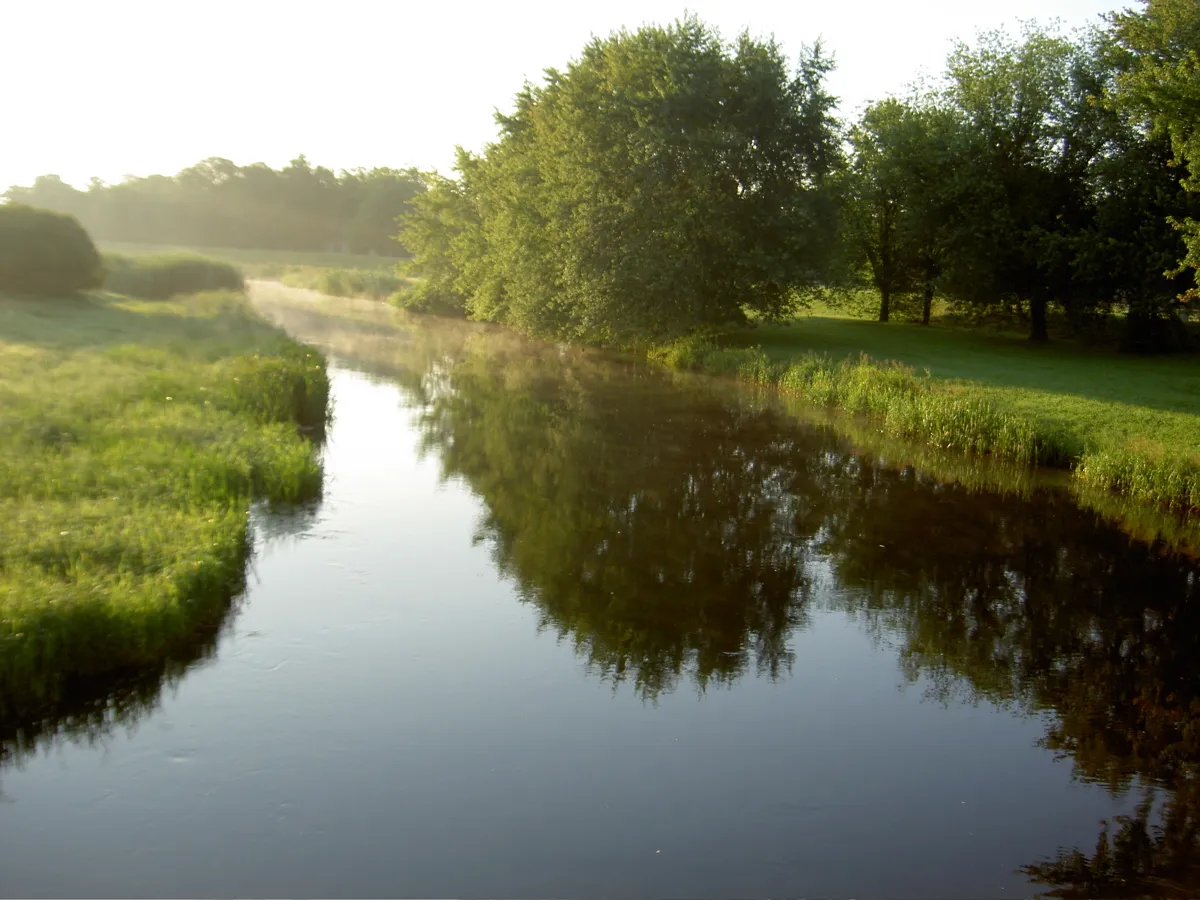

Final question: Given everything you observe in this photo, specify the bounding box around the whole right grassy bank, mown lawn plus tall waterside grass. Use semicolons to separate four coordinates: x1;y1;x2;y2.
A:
652;317;1200;510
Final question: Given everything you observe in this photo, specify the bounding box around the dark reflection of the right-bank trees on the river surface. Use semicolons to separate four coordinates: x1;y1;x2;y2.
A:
253;292;1200;896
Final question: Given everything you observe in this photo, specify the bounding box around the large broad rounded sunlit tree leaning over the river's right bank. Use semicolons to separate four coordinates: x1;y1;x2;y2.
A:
401;18;838;344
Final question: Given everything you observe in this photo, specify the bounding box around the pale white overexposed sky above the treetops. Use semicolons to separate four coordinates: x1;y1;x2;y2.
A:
0;0;1118;191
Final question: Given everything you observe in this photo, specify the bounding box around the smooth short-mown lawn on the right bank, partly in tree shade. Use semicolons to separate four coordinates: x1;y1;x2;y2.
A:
733;316;1200;461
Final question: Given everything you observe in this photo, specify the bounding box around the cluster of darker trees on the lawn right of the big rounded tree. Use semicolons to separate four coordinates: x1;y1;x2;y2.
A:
840;22;1200;352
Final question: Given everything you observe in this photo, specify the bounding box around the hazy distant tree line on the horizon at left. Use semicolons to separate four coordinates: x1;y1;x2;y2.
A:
5;156;426;256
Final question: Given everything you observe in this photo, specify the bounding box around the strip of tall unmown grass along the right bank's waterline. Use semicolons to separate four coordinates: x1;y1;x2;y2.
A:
650;337;1200;510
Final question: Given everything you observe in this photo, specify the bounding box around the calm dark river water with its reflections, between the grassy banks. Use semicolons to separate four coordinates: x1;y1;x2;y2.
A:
0;292;1200;898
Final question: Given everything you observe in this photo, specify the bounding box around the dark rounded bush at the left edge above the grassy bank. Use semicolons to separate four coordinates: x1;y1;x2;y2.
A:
0;203;103;296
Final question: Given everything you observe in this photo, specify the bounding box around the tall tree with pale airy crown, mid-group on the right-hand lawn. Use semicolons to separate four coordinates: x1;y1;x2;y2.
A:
944;28;1096;341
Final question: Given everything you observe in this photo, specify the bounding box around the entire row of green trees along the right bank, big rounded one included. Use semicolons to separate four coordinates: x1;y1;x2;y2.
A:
401;0;1200;349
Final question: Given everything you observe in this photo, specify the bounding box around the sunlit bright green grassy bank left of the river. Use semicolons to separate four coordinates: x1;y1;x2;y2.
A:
0;293;329;721
